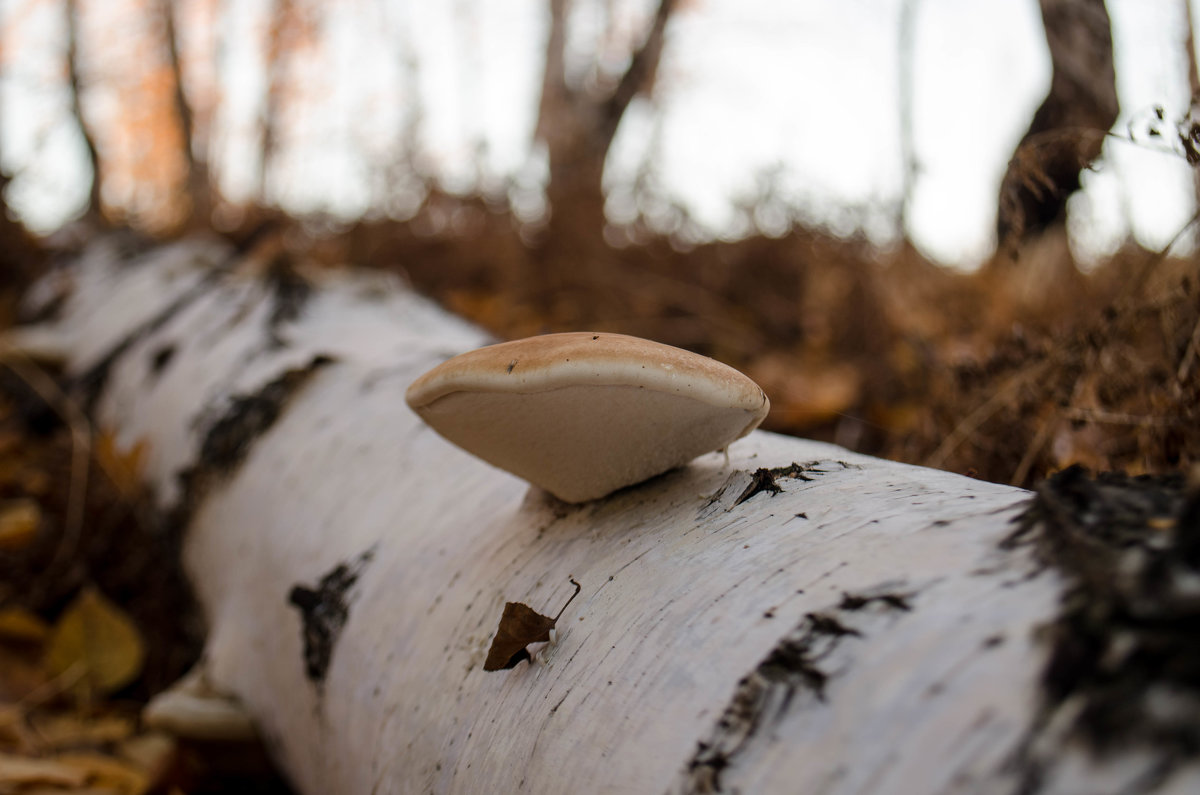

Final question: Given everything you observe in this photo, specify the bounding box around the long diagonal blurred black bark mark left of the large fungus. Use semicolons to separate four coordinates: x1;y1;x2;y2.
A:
170;354;334;533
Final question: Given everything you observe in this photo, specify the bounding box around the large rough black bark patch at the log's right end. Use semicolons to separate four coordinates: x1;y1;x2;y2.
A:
1003;466;1200;793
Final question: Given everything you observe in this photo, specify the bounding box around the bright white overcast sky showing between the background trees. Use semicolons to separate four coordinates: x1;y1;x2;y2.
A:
0;0;1194;265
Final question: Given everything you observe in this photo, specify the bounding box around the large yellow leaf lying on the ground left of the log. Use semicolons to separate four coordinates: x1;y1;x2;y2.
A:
46;588;145;700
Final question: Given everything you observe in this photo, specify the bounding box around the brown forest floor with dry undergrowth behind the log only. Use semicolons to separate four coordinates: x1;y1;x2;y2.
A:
321;193;1200;488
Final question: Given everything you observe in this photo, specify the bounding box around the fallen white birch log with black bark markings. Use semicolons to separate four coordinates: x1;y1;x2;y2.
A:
22;239;1200;794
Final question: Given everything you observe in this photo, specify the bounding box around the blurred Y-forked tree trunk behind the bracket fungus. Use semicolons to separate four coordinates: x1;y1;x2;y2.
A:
534;0;676;293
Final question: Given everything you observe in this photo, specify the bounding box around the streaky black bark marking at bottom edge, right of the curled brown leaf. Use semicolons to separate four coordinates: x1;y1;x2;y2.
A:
672;588;908;795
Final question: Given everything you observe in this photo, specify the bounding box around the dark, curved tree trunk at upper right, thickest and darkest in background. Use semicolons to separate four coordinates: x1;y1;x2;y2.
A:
997;0;1120;255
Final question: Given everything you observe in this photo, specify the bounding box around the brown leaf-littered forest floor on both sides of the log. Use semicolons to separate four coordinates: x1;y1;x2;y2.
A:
0;202;1200;795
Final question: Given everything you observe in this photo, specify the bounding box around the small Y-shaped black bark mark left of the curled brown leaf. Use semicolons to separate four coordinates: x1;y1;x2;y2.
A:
288;548;374;688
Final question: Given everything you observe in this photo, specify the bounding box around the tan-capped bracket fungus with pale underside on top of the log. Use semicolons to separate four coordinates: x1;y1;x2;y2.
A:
406;331;770;502
